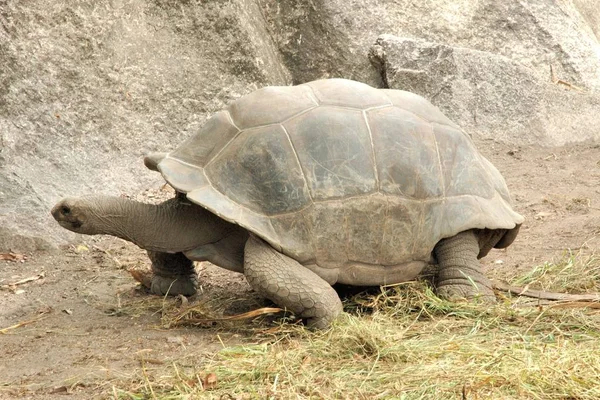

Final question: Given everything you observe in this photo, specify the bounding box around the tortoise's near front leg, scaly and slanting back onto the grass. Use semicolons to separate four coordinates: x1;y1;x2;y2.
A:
244;235;342;329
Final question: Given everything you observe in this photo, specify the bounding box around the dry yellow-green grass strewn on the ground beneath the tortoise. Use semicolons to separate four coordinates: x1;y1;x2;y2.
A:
110;254;600;399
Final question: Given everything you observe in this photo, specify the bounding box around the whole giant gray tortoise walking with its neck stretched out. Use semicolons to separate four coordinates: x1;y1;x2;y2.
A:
52;79;523;328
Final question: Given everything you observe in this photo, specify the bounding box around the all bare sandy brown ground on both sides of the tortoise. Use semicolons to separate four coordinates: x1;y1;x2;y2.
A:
0;141;600;399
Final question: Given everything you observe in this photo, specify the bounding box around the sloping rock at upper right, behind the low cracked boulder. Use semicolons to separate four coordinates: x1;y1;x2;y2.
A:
261;0;600;90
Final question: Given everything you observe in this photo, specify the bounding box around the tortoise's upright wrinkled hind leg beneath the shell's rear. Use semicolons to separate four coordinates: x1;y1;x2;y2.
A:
434;231;496;303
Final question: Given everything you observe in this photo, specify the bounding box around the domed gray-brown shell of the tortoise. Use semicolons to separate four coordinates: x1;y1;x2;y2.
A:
152;79;523;278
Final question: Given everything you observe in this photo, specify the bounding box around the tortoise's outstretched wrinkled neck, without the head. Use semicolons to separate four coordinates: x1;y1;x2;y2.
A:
88;196;234;253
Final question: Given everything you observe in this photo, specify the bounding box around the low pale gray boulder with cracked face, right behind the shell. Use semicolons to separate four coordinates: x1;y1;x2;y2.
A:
371;35;600;145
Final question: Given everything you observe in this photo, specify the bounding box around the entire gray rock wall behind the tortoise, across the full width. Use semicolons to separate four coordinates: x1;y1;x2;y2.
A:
0;0;600;247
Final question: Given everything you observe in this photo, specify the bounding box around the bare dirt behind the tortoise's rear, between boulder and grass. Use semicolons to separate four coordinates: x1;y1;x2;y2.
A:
478;141;600;276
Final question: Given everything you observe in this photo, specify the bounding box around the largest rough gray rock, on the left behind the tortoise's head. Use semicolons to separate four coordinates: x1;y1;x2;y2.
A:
0;0;290;251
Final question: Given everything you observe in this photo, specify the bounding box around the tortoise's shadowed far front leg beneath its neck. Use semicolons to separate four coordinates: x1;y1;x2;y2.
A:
148;251;198;296
